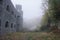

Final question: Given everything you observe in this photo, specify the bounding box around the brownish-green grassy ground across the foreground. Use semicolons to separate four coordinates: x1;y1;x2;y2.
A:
0;32;60;40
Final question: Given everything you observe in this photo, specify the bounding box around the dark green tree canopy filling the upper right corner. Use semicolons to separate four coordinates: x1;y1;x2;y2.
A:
48;0;60;21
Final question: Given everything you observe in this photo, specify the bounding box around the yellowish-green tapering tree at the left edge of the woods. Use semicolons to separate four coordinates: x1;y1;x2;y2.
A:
40;11;50;31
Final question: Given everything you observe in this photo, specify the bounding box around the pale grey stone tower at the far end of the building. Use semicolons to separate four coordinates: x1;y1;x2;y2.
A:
16;5;23;31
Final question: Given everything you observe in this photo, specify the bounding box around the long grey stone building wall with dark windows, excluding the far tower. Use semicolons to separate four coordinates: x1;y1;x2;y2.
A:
0;0;21;35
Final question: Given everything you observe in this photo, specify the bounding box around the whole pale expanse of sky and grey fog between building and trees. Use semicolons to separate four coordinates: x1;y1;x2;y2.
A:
11;0;43;30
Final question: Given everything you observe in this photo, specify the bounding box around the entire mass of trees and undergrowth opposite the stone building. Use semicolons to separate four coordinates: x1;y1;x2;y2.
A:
40;0;60;32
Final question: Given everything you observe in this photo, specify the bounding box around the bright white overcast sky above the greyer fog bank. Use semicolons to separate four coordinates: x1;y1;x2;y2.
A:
12;0;42;19
